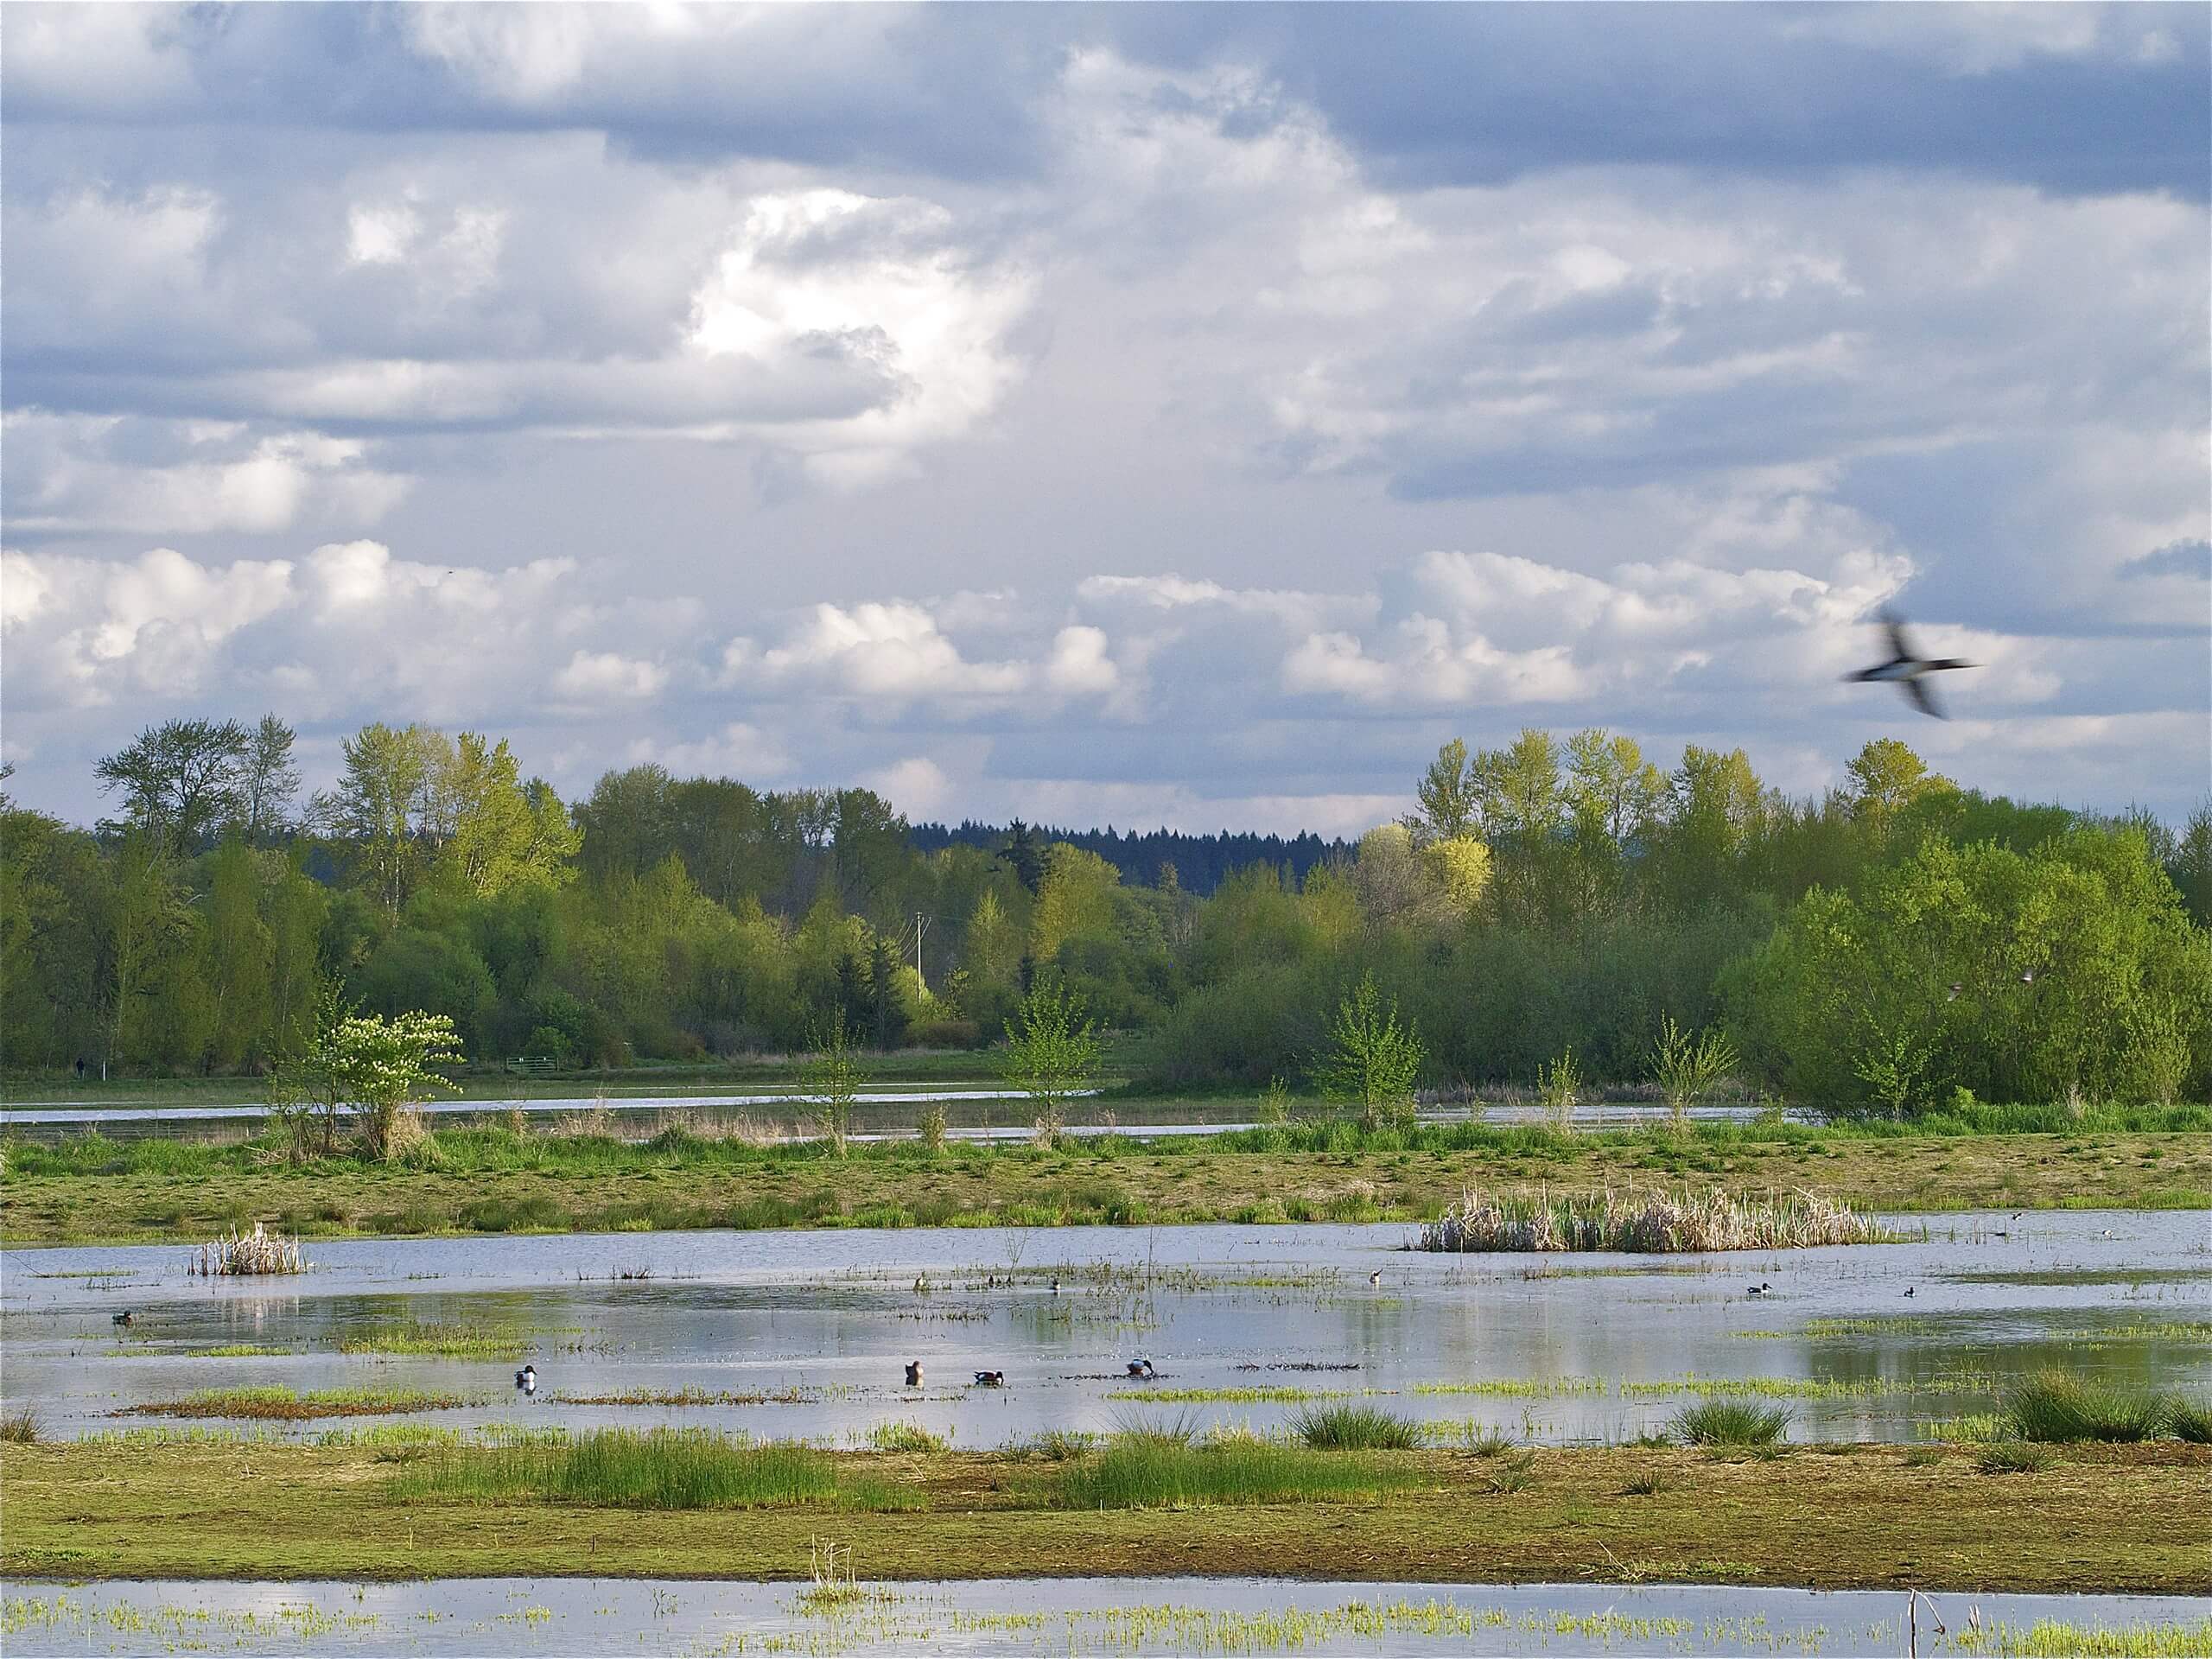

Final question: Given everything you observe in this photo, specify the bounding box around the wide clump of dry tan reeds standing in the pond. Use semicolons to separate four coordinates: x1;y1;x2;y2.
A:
1418;1188;1891;1255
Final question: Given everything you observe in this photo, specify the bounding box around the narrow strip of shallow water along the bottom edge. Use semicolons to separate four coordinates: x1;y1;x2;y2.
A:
0;1580;2212;1655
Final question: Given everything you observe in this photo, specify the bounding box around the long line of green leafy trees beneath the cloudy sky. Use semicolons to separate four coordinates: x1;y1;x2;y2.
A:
0;715;2212;1113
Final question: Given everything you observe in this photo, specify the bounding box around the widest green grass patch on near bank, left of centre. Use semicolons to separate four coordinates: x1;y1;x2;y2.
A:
394;1429;923;1510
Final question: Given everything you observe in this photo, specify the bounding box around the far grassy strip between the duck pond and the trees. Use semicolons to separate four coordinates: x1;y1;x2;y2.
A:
0;1130;2212;1243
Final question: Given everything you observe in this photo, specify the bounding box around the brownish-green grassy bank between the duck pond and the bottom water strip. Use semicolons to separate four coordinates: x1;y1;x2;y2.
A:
0;1442;2212;1595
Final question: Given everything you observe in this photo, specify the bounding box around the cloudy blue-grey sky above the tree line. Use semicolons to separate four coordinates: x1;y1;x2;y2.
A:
0;3;2212;834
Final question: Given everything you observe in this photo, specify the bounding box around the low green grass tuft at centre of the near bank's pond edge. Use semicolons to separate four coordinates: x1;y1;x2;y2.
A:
1048;1438;1421;1509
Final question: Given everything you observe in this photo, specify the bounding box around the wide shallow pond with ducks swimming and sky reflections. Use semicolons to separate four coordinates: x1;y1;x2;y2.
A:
0;1210;2212;1449
